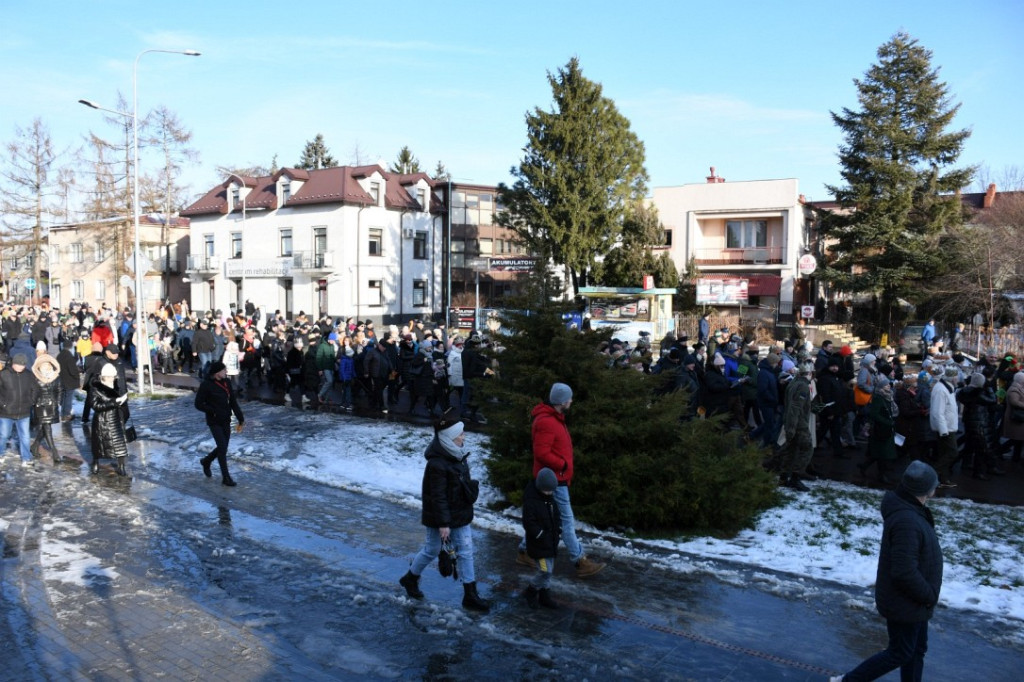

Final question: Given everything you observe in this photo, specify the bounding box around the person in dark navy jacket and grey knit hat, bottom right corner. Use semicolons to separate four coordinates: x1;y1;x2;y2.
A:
830;460;942;682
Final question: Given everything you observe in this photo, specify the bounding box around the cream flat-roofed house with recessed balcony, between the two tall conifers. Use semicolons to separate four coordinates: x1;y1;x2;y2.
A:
651;168;809;317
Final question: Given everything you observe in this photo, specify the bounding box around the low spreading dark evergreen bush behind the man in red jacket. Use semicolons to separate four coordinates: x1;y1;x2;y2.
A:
480;307;776;534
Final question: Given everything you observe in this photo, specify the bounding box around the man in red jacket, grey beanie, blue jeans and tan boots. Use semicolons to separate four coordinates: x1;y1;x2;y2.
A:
516;384;605;578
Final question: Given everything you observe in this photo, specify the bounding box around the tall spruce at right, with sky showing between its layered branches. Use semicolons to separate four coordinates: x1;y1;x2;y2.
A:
821;33;973;329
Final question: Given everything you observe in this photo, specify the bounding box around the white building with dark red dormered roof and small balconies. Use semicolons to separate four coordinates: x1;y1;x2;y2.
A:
182;165;446;323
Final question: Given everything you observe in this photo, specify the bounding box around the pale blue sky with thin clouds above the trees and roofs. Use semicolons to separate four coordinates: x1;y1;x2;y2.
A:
0;0;1024;200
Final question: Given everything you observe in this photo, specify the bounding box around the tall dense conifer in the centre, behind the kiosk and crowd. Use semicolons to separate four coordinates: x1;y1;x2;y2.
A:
498;57;647;293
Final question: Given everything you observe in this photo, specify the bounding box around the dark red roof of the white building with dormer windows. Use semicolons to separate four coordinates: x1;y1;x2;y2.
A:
181;165;441;215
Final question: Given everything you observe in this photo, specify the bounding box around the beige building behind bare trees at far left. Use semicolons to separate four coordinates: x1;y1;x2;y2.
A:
44;215;188;312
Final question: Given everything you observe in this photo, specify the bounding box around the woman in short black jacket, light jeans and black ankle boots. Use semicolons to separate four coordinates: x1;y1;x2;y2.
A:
398;413;490;613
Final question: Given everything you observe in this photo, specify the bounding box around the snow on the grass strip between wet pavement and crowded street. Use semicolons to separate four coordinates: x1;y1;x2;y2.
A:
134;393;1024;638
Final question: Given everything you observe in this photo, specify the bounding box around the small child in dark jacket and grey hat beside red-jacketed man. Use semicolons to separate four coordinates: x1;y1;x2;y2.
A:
522;467;561;608
